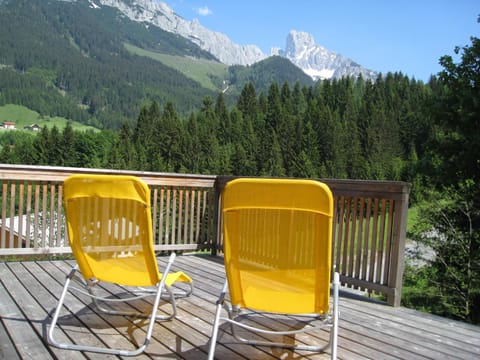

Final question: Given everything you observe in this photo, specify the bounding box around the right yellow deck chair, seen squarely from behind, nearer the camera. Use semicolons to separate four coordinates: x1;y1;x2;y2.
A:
209;178;339;359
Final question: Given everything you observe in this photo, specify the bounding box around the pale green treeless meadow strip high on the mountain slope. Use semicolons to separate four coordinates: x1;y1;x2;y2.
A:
125;44;228;91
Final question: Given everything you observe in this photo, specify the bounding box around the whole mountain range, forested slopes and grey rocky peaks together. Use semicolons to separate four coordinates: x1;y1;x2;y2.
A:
0;0;375;128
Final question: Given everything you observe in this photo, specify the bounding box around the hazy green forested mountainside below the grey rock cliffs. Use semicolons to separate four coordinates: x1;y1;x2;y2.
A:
0;0;313;129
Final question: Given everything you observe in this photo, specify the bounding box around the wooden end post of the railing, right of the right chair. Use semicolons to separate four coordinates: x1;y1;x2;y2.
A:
387;185;410;306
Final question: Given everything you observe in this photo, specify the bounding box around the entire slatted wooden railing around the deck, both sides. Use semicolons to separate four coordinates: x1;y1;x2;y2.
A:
0;165;410;306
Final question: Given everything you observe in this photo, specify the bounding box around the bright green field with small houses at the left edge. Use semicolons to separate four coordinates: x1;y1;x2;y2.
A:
0;104;98;131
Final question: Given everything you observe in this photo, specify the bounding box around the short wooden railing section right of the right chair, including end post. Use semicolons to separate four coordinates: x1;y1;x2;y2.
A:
324;180;410;306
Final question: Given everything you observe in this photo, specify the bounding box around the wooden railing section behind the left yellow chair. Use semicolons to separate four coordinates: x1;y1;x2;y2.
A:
0;165;216;255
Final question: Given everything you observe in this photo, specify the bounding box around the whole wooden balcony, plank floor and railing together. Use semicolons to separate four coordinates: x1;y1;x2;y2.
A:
0;165;480;359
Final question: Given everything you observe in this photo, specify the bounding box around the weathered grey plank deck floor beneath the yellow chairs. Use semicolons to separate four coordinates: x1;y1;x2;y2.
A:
0;255;480;360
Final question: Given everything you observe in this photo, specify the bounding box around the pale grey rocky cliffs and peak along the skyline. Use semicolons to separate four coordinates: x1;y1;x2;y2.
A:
94;0;377;80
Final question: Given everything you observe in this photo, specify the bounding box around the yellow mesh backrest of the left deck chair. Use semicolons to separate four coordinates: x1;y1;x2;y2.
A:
64;175;159;286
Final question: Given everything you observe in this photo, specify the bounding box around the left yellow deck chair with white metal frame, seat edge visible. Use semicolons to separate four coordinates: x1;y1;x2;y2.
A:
48;175;193;356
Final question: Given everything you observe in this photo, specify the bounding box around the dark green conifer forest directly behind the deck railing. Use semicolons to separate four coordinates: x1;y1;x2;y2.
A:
0;38;480;323
